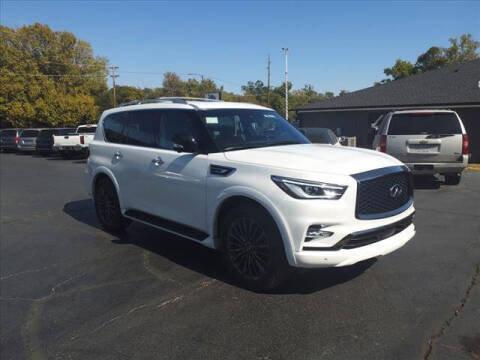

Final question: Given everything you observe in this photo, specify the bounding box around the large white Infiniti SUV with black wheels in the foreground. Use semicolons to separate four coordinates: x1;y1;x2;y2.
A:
86;98;415;289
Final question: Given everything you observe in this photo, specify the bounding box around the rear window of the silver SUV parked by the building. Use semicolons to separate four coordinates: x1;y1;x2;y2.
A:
388;113;462;135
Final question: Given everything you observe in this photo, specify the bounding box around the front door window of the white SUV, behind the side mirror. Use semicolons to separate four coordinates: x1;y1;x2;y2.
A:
159;110;202;150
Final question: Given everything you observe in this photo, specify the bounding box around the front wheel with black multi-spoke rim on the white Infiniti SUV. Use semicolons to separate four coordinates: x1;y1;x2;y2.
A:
221;204;290;291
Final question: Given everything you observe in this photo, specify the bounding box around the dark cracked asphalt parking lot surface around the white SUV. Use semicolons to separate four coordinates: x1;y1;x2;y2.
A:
0;154;480;360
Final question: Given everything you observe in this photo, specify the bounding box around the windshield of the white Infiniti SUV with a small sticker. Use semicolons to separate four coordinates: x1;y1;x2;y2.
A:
200;109;310;151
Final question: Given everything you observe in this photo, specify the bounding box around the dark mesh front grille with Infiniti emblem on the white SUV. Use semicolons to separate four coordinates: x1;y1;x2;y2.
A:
353;166;413;219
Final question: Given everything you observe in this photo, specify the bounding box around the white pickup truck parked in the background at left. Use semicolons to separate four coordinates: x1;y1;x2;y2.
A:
53;124;97;158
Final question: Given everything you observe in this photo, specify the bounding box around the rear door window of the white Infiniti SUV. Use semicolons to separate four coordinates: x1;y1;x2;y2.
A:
123;110;161;147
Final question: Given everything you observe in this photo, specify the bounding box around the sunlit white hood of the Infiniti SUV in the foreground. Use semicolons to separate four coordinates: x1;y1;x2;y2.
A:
224;144;402;175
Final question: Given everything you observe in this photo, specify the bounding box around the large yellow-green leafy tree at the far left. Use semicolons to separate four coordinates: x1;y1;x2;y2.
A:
0;23;108;127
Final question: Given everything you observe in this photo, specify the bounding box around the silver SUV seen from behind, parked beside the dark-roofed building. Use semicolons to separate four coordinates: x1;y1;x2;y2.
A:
372;110;469;185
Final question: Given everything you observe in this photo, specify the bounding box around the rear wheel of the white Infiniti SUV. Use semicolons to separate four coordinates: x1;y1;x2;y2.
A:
94;177;131;233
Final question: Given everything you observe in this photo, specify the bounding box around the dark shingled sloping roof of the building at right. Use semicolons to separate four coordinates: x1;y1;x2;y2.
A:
296;59;480;110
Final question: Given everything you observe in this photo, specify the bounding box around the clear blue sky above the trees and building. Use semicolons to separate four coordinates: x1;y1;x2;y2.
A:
0;0;480;94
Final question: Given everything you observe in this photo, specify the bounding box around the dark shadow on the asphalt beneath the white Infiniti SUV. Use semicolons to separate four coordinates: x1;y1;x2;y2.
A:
63;199;376;294
